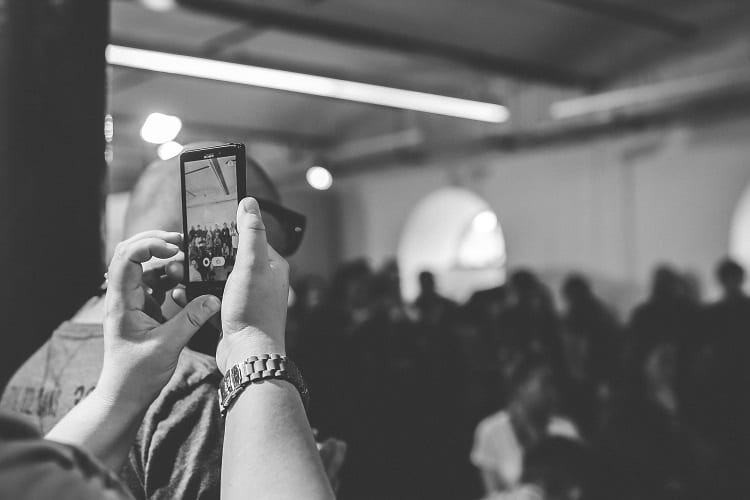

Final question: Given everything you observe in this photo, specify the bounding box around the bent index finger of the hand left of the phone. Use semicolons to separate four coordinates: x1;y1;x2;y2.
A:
107;238;179;308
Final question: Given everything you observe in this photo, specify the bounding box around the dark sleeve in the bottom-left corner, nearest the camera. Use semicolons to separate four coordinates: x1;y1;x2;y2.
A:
0;416;132;500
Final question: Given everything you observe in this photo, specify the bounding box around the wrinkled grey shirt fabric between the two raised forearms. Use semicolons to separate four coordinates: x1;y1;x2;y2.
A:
121;382;224;500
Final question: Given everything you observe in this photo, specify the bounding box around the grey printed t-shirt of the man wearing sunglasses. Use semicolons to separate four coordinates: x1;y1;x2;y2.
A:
0;322;224;499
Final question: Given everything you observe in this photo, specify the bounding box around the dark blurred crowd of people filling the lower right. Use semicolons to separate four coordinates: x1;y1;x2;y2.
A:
287;260;750;500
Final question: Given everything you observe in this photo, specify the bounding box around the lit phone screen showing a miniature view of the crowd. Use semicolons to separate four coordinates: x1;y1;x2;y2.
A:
183;152;239;283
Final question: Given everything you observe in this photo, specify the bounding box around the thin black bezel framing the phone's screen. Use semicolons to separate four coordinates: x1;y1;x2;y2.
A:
180;143;247;300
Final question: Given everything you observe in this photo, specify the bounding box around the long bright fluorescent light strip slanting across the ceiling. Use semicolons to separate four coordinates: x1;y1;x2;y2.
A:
106;45;510;123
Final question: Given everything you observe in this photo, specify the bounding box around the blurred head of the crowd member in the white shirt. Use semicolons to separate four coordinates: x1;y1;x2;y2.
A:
508;355;557;422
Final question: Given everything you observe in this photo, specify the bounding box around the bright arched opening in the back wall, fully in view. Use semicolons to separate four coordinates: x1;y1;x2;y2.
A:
398;188;506;302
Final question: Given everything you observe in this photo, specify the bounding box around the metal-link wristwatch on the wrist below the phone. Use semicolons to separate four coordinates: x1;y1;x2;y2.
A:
219;354;310;417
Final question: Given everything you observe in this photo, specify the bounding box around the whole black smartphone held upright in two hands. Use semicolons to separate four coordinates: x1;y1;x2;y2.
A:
180;144;246;300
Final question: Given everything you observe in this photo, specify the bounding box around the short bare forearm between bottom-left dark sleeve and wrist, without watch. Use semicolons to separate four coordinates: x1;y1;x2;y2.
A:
45;389;148;472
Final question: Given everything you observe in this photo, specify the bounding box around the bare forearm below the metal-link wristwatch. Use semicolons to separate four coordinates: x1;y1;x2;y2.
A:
221;380;334;500
